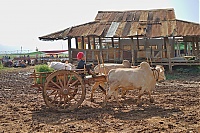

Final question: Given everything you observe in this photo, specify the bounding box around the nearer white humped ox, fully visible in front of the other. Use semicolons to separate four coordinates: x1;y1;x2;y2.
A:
104;62;166;106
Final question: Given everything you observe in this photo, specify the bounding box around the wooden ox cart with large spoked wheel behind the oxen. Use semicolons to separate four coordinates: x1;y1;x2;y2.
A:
30;69;106;111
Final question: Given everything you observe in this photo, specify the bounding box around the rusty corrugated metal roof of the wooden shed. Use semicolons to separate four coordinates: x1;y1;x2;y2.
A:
39;9;200;40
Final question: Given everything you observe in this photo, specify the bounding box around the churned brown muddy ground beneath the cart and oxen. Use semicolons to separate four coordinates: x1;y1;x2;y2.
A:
0;68;200;133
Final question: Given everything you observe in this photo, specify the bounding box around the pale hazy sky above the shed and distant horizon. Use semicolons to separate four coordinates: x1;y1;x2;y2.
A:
0;0;200;54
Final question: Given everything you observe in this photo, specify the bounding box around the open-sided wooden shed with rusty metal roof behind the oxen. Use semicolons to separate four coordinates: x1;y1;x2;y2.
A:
39;8;200;70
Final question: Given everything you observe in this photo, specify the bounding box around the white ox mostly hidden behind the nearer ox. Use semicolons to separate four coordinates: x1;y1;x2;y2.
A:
90;60;131;102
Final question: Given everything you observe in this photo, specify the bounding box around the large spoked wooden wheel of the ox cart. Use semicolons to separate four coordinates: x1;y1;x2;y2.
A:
43;70;86;111
